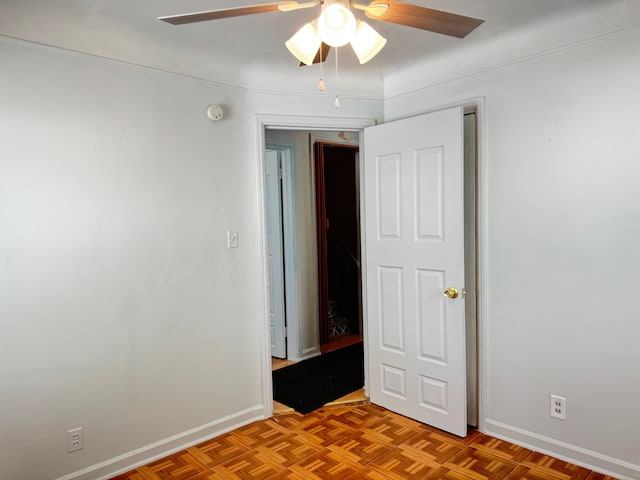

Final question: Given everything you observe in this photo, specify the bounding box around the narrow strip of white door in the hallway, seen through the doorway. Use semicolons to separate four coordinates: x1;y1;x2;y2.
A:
265;150;287;358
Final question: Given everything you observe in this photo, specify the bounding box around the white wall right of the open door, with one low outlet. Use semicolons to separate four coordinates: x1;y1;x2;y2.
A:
385;28;640;478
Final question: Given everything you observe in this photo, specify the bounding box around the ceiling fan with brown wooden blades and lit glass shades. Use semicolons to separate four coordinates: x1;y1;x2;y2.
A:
158;0;484;65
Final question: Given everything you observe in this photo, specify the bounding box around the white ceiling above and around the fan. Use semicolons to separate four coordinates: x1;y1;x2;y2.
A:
0;0;637;95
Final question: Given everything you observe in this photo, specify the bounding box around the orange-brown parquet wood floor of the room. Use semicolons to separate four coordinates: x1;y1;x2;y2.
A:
113;402;615;480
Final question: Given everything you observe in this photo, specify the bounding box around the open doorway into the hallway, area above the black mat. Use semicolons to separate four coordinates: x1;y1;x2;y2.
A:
265;129;364;411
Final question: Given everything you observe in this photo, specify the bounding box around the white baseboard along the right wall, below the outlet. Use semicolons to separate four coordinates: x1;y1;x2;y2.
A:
484;419;640;480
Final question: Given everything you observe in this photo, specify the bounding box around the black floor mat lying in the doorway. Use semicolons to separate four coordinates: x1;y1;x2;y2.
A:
272;342;364;414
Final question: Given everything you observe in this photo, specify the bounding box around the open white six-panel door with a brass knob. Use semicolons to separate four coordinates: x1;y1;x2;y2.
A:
364;108;467;436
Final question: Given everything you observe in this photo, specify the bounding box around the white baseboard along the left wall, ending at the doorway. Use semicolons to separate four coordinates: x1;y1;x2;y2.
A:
56;405;265;480
